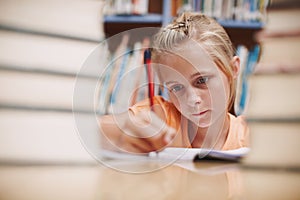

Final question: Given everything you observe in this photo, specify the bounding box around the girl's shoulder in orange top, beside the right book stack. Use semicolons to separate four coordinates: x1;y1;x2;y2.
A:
223;114;249;150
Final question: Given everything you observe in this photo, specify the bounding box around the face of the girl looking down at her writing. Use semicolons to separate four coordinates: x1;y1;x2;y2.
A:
158;41;229;128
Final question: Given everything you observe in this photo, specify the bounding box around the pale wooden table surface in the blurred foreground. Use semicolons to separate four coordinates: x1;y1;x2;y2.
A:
0;161;300;200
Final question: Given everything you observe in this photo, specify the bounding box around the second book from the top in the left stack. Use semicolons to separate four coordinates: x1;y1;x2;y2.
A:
0;30;106;77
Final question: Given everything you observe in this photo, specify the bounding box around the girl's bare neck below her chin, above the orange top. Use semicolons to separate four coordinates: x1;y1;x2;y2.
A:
189;113;230;149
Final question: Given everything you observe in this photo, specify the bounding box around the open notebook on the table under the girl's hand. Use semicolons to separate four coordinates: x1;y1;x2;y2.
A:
101;147;250;161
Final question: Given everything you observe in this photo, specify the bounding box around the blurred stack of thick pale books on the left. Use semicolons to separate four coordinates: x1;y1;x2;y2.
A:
0;0;105;163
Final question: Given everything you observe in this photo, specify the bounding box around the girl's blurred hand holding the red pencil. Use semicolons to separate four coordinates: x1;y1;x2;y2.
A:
101;110;176;153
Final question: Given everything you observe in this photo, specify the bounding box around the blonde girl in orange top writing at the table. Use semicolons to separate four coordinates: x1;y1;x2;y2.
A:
100;12;249;153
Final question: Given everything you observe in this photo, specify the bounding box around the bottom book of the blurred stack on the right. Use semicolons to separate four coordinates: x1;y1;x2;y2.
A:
242;120;300;169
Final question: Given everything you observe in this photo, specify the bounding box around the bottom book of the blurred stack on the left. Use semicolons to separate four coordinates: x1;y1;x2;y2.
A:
0;109;97;164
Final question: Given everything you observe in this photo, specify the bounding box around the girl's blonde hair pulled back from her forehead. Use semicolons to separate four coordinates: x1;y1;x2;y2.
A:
152;12;236;110
